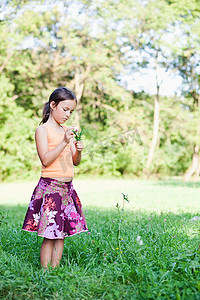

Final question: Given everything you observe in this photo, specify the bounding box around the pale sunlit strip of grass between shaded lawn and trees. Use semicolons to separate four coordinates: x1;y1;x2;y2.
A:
0;179;200;213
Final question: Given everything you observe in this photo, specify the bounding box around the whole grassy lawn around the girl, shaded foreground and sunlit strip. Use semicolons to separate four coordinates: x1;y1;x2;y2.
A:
0;180;200;300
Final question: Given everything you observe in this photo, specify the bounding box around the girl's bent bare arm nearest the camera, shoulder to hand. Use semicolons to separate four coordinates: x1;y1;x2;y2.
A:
35;126;73;167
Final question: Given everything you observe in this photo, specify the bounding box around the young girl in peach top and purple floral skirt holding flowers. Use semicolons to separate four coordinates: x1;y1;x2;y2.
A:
22;87;88;268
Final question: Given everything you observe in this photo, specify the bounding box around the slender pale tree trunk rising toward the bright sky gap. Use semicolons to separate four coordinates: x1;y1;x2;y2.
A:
147;86;160;170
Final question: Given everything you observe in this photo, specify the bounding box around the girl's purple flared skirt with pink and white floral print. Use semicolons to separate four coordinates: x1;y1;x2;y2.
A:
22;177;88;239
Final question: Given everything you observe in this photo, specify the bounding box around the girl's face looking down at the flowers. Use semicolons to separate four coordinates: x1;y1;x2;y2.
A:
51;100;76;124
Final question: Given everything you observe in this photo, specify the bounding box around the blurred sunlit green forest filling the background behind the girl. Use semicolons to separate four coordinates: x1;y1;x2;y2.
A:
0;0;200;181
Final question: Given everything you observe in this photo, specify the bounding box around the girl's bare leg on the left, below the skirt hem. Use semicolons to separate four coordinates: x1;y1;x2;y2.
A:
40;238;54;269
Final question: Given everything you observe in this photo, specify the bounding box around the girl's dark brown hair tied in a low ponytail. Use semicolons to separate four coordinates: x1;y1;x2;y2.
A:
40;87;77;124
